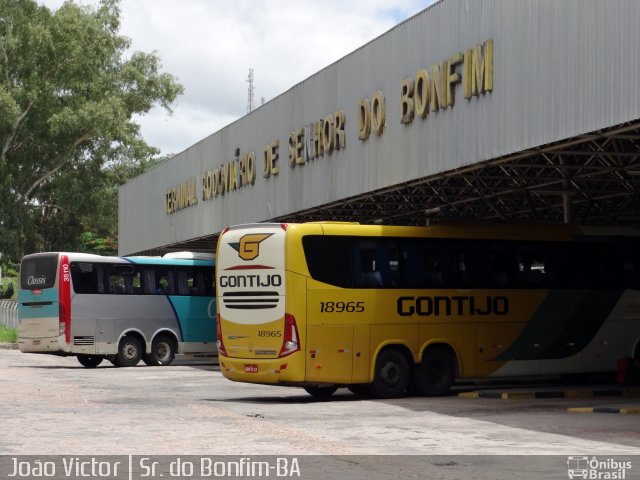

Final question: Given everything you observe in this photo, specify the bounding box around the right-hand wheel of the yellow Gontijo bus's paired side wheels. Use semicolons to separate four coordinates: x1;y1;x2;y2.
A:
413;348;456;397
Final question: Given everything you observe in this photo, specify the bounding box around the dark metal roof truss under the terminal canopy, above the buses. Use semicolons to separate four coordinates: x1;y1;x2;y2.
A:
151;120;640;252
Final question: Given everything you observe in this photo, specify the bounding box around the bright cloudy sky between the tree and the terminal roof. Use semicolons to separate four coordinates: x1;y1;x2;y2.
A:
38;0;434;155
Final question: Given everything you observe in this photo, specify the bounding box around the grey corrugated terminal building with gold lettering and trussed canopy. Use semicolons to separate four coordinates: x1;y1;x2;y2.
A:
118;0;640;255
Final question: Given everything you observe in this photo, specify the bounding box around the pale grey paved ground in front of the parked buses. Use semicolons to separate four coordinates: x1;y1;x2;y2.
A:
0;349;640;480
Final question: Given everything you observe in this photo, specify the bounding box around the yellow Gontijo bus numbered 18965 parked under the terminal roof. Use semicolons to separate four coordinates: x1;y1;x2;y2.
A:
216;222;640;398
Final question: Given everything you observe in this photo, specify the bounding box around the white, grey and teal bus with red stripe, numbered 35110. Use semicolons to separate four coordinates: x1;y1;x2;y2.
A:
18;252;217;368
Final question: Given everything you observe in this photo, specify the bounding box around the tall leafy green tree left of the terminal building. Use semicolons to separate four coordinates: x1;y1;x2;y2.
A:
0;0;183;258
